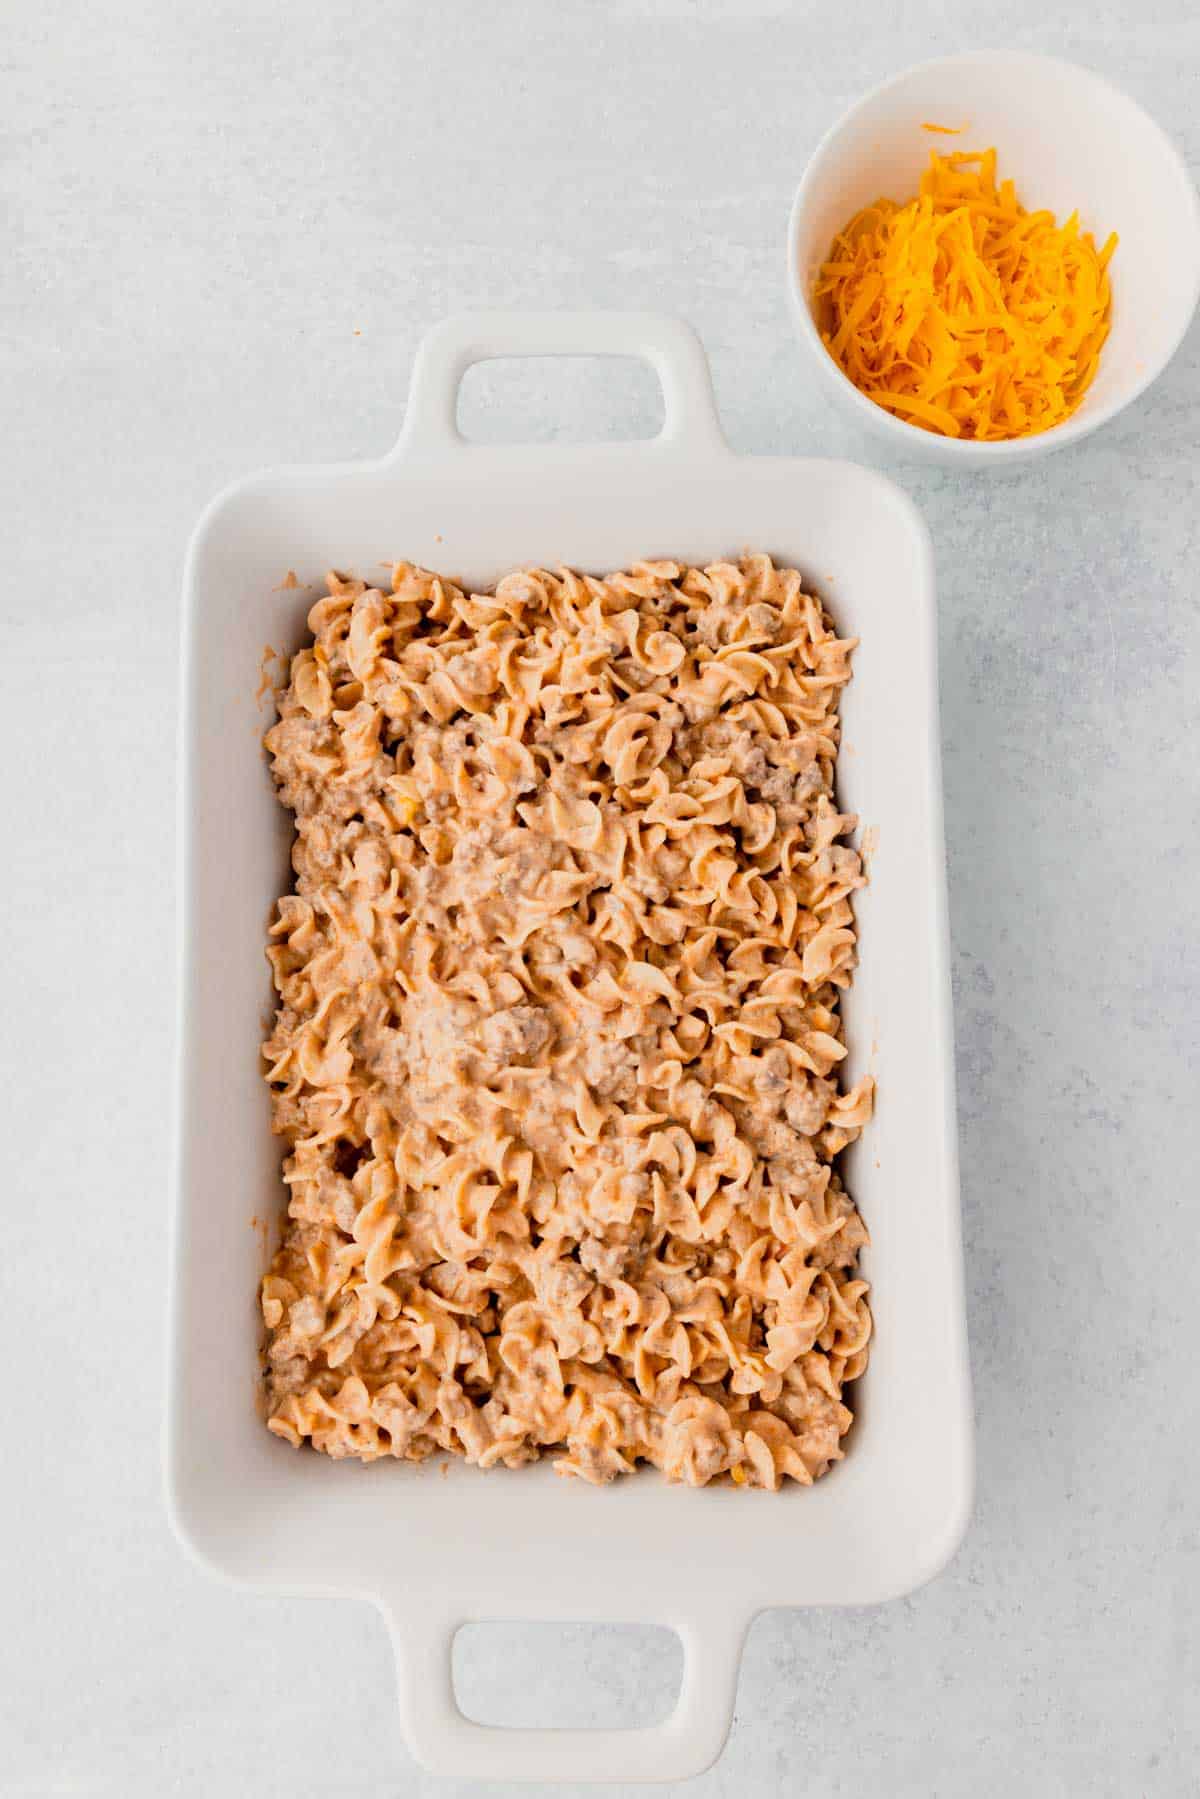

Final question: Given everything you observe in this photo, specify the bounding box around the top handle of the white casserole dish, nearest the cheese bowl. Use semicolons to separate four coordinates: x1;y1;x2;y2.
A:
389;311;729;461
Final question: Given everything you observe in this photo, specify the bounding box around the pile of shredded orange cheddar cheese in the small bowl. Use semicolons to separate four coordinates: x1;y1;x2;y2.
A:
815;149;1117;443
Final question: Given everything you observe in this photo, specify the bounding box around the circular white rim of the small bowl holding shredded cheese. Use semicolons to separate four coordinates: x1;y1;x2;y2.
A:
786;50;1200;462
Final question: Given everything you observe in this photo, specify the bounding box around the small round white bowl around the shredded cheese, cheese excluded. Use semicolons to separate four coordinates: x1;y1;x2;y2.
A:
788;50;1200;468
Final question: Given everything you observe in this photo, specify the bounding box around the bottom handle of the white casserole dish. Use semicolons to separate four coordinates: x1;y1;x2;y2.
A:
383;1594;750;1783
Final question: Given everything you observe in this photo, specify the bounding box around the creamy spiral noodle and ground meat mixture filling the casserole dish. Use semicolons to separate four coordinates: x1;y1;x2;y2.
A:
261;556;873;1488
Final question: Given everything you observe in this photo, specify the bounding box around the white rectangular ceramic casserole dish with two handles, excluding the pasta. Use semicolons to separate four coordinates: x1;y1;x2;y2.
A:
167;313;973;1781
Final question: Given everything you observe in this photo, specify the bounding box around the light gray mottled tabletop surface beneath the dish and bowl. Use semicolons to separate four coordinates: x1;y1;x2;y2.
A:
0;0;1200;1799
